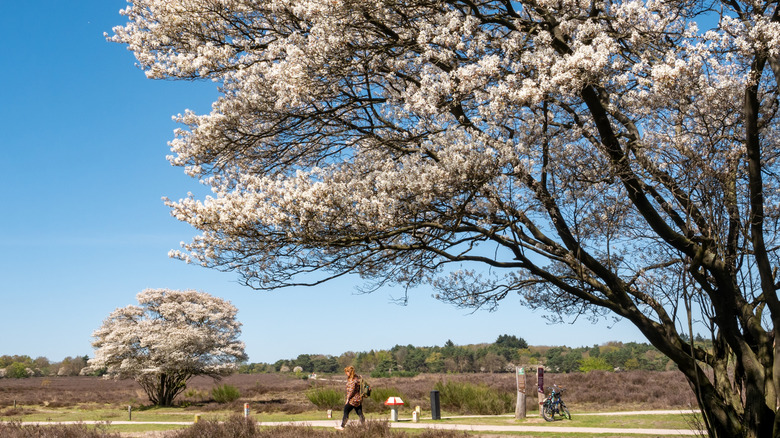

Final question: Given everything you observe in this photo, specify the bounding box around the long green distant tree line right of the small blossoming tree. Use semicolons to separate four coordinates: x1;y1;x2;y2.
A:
239;335;706;377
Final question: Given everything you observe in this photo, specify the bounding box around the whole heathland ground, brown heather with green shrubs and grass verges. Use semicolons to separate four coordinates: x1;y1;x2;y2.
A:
0;371;695;438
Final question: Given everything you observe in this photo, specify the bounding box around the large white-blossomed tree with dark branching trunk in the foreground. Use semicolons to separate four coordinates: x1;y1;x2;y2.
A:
109;0;780;437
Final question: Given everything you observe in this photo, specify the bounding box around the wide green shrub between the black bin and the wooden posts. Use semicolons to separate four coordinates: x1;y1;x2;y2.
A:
434;381;514;415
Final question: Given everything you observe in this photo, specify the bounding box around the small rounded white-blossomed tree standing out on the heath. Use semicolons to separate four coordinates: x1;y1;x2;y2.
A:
89;289;247;406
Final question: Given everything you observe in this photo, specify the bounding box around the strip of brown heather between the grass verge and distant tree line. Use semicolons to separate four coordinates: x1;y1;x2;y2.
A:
0;371;696;414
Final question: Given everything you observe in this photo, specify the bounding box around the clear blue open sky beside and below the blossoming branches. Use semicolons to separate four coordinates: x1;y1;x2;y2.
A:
0;0;644;362
